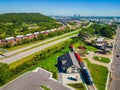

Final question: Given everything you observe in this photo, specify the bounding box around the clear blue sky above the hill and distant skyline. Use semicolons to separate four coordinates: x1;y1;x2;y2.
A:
0;0;120;16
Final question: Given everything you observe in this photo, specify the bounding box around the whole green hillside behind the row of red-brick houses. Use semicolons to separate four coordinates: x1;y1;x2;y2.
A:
0;13;61;39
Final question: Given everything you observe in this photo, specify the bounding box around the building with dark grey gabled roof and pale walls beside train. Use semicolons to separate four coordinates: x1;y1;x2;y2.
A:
58;52;80;73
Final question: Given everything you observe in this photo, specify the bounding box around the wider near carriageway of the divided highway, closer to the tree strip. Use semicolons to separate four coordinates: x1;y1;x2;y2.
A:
0;35;77;64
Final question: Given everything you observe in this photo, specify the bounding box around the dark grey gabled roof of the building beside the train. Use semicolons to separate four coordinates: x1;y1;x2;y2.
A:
59;52;80;69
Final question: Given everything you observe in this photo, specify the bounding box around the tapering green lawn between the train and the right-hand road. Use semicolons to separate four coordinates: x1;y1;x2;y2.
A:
84;58;108;90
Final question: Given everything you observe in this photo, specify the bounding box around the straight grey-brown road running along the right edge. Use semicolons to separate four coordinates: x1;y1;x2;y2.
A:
110;28;120;90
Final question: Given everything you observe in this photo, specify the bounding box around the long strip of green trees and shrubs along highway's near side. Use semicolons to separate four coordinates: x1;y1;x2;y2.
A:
0;40;76;85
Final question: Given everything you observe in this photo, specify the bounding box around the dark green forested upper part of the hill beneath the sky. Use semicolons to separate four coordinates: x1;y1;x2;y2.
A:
0;13;56;24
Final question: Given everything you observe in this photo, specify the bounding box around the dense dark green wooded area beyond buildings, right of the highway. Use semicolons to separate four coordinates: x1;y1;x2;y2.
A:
79;24;117;38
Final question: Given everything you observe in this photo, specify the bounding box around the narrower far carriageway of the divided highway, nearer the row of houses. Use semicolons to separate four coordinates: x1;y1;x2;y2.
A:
0;30;79;58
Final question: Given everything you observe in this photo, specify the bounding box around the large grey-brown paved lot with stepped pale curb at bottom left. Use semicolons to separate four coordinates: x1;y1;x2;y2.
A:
0;69;73;90
